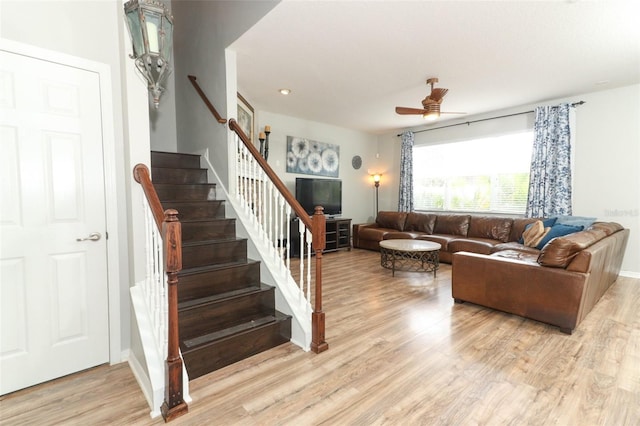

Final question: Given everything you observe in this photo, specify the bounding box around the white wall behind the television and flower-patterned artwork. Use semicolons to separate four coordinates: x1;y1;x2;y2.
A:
258;110;384;223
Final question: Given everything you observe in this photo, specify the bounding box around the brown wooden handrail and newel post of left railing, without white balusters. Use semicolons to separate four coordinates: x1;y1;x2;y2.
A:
133;164;189;422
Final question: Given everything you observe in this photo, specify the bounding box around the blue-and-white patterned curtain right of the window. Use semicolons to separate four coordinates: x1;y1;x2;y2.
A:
525;104;571;217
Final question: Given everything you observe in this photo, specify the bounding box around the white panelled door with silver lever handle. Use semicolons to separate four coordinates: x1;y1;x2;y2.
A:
0;51;109;394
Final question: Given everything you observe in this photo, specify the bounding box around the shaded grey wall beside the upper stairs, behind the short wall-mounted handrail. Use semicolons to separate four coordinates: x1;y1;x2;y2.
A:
172;0;278;186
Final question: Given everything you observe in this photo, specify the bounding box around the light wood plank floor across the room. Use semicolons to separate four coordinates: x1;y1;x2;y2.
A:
0;250;640;426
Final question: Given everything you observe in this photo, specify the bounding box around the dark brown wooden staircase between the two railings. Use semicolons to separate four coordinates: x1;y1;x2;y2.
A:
151;152;291;379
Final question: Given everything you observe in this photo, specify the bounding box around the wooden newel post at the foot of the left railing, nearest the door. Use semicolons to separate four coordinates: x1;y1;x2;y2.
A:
161;209;189;422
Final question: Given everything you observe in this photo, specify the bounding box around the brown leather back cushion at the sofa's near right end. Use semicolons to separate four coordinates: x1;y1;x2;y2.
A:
538;229;607;268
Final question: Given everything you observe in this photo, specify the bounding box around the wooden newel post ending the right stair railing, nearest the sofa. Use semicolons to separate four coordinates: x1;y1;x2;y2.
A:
311;206;329;354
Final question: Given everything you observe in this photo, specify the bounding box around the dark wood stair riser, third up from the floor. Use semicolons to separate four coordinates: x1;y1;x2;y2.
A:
178;262;260;302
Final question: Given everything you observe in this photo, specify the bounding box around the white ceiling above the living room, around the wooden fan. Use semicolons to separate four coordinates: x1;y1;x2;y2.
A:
232;0;640;134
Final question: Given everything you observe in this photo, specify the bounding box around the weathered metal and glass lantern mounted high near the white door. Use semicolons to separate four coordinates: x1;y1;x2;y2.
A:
124;0;173;108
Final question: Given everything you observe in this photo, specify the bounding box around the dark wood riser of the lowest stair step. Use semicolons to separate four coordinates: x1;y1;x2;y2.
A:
183;318;291;380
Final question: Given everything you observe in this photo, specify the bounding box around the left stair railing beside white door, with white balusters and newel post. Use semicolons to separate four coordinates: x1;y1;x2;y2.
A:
133;164;188;422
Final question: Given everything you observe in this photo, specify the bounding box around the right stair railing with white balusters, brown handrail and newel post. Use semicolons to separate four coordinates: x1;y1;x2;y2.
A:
229;119;329;353
